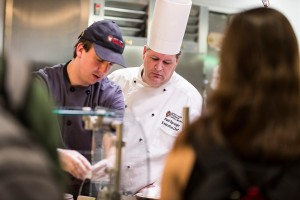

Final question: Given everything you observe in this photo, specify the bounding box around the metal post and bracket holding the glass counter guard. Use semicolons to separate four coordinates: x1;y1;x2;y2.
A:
53;107;124;200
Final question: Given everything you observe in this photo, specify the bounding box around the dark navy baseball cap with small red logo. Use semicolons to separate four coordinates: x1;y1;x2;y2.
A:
78;20;126;67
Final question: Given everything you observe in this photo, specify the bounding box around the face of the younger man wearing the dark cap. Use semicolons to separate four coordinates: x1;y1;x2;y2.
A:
77;43;113;85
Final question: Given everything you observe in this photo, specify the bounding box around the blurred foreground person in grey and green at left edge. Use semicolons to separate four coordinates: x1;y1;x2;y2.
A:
0;52;65;200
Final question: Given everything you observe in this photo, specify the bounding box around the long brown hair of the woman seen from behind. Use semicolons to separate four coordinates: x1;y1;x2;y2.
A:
176;8;300;159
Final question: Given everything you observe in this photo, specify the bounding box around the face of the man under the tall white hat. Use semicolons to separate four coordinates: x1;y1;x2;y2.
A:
142;46;179;87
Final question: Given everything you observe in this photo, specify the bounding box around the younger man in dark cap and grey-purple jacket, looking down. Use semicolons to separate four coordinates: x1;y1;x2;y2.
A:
36;20;125;199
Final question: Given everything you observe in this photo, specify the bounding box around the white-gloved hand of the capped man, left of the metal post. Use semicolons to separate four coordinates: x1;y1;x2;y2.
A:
57;149;92;180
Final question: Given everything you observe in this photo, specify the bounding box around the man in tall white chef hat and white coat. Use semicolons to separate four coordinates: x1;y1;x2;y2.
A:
109;0;203;198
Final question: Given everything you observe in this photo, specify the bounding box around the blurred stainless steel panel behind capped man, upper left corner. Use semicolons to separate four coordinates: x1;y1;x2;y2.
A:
4;0;89;68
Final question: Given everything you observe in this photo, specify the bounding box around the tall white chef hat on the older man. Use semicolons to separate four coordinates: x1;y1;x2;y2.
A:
148;0;192;55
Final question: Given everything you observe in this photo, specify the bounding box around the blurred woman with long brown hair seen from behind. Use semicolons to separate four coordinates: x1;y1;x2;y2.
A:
161;8;300;200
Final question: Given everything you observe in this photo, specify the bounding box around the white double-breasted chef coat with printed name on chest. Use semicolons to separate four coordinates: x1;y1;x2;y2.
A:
108;65;202;193
